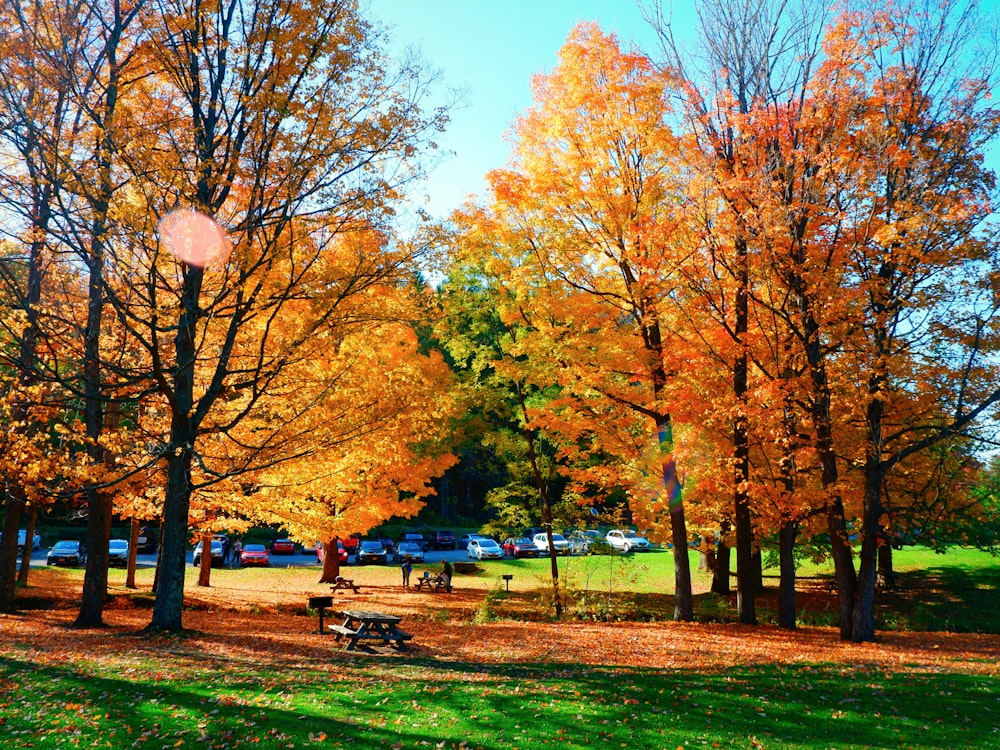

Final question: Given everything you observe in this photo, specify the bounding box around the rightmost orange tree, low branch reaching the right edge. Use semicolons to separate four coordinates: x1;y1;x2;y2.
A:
828;2;1000;641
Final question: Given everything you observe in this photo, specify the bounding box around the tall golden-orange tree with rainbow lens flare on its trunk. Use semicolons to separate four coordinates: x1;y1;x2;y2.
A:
452;24;693;620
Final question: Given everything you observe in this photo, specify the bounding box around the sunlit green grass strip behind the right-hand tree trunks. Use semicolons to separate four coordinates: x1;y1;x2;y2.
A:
458;547;1000;633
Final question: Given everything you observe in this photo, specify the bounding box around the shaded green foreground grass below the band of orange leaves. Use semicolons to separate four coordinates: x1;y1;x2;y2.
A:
0;650;1000;750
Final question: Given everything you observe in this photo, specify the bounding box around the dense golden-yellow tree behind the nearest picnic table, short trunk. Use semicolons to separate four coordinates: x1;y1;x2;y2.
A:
242;308;455;582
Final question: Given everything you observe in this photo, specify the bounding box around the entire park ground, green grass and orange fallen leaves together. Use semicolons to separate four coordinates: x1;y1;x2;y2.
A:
0;550;1000;750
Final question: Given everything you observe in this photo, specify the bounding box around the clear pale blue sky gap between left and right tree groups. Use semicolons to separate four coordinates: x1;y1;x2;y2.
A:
370;0;664;217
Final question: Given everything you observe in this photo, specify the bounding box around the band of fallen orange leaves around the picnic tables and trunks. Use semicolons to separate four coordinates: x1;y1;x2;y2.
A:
0;570;1000;675
